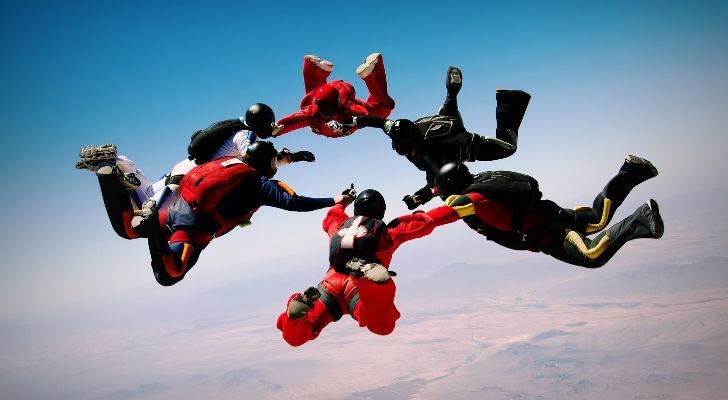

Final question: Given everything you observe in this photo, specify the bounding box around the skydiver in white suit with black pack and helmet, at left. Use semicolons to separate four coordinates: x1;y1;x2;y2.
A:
76;103;315;239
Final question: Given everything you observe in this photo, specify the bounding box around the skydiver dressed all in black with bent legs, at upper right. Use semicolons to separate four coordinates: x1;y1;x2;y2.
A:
354;66;531;210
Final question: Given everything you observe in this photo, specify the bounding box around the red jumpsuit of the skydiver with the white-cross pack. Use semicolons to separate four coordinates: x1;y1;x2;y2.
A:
277;204;459;346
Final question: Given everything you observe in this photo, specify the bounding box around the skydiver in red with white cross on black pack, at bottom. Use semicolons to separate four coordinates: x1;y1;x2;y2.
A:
277;189;457;346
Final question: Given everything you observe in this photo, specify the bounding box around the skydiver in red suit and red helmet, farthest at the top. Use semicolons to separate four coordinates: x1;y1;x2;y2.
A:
276;53;394;138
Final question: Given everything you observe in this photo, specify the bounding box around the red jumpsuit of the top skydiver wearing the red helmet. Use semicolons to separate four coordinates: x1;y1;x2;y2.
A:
276;56;394;138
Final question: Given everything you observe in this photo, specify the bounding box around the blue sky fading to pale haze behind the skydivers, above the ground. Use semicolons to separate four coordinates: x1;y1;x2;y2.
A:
0;1;728;396
